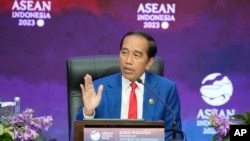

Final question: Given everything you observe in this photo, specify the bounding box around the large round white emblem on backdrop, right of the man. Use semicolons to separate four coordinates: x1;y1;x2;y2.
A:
200;73;233;106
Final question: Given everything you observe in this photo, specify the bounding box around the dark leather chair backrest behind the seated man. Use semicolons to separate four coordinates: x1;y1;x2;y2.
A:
67;55;164;132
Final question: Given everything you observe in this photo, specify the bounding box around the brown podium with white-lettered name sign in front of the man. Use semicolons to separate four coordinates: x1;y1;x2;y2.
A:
73;119;164;141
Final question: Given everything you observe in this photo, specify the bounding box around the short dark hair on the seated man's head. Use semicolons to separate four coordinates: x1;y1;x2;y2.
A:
120;30;157;58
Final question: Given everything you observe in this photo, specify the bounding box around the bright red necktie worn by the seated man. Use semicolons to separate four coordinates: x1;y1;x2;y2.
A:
128;82;137;119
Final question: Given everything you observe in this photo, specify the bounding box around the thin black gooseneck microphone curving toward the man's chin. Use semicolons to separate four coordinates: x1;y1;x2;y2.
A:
137;78;177;141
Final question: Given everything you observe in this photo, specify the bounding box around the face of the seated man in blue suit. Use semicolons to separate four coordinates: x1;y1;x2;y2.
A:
120;35;154;81
